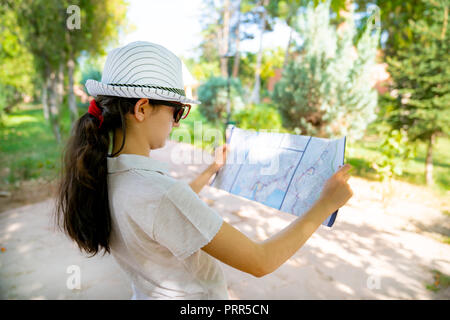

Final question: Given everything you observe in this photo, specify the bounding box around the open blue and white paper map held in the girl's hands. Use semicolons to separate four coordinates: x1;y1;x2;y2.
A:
210;126;346;227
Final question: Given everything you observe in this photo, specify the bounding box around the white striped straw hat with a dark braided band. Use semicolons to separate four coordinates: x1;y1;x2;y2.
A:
86;41;201;104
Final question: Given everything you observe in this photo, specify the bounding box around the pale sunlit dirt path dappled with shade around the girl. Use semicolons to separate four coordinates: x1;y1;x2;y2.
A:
0;142;450;299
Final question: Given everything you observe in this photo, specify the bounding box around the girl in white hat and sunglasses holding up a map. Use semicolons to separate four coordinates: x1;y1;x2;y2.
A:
55;42;352;299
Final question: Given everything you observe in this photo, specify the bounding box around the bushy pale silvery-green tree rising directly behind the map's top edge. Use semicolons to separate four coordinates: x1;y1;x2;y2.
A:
273;1;379;139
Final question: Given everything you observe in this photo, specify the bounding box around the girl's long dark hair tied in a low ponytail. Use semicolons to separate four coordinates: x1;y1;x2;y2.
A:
54;96;148;257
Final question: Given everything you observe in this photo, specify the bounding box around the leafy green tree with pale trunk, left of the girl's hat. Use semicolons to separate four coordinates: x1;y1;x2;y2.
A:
0;0;129;142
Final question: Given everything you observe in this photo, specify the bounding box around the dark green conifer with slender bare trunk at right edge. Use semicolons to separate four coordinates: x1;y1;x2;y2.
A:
381;0;450;184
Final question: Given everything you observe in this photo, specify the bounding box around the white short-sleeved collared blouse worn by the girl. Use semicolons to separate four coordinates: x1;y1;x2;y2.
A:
107;154;225;299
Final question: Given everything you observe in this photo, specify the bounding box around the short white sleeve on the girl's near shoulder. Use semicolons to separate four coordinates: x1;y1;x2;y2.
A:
153;181;223;260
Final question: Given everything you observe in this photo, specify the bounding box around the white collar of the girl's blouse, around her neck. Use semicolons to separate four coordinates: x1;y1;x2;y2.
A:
106;153;169;175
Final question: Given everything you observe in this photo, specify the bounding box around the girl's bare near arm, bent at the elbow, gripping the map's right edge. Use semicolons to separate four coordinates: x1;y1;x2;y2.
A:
202;165;353;278
